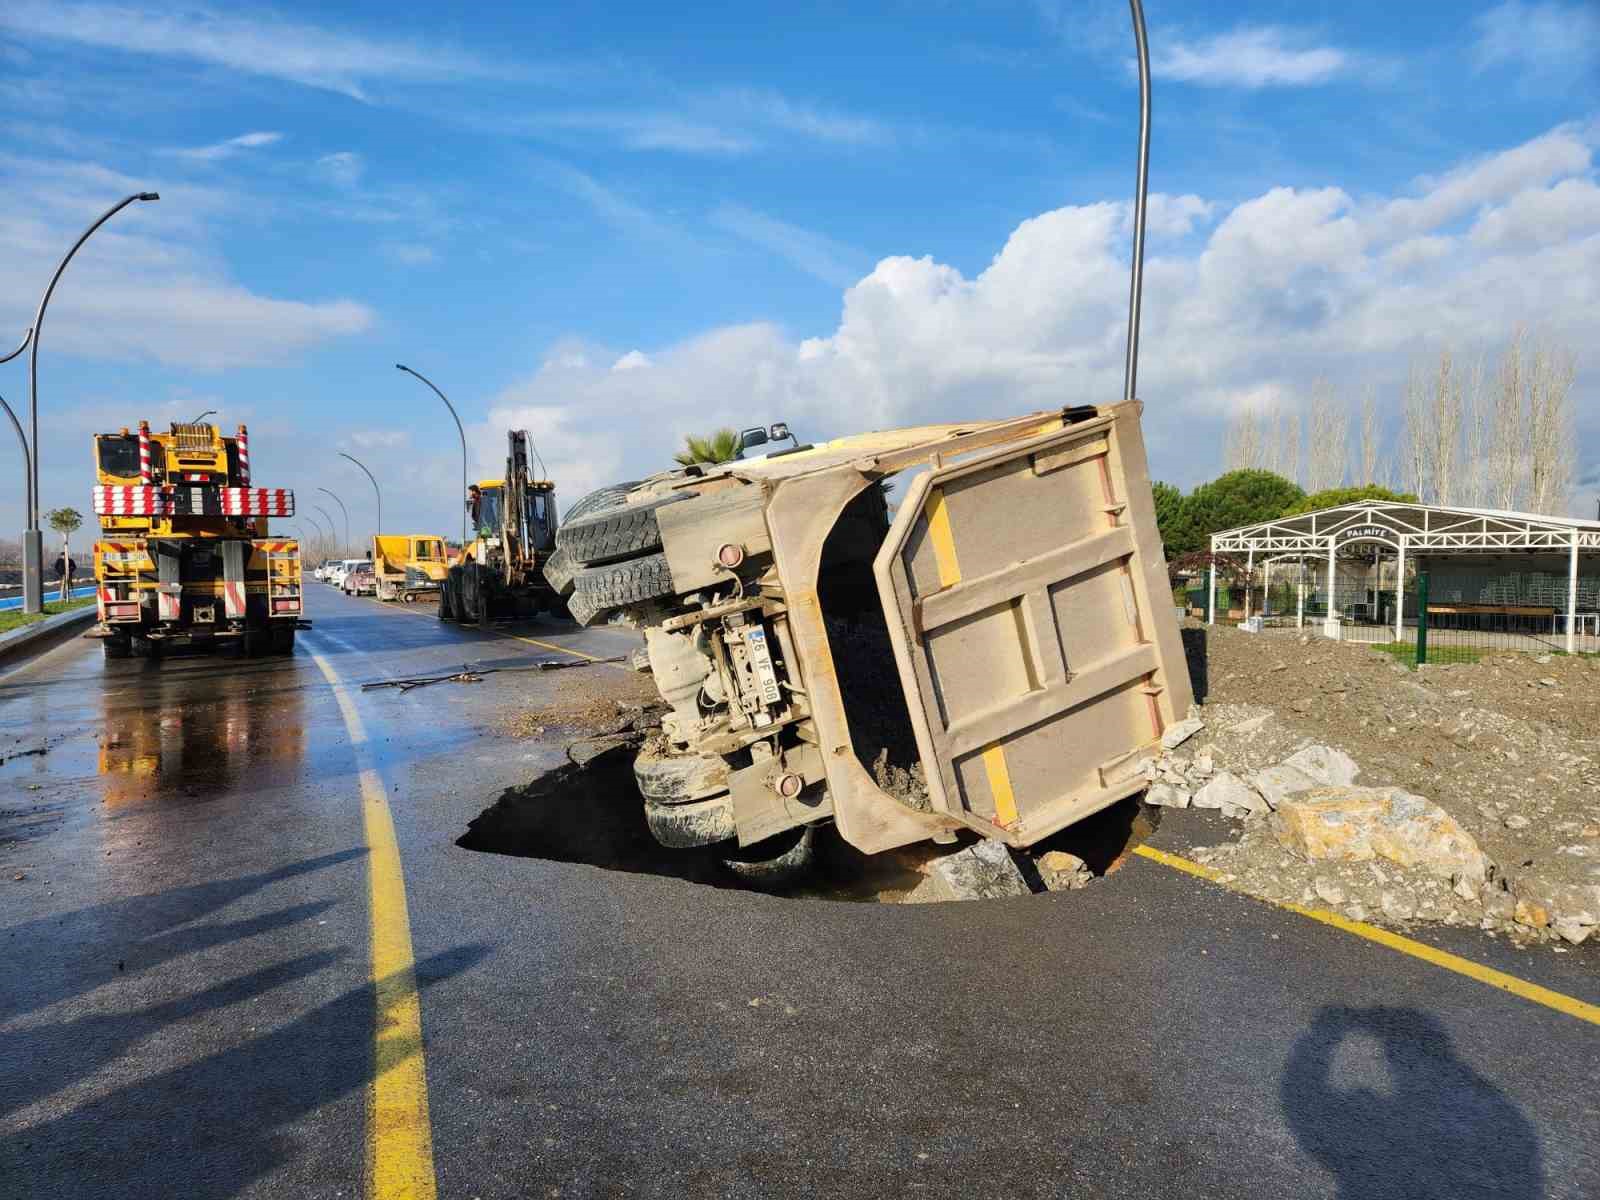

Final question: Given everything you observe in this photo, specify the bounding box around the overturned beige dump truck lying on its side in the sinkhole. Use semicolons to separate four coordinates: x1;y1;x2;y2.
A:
552;403;1190;878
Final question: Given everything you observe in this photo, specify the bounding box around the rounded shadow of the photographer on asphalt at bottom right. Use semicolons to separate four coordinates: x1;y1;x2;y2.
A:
1280;1006;1544;1200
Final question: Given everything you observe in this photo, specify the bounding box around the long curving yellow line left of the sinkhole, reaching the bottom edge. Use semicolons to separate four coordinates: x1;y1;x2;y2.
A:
312;654;437;1200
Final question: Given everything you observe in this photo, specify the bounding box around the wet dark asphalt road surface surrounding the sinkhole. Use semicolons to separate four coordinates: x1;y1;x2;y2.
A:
0;587;1600;1200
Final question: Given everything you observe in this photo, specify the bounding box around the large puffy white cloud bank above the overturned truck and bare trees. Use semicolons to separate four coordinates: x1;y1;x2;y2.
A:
473;131;1600;498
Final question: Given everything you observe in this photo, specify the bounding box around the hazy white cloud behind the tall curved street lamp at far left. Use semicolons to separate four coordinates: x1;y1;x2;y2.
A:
0;155;374;368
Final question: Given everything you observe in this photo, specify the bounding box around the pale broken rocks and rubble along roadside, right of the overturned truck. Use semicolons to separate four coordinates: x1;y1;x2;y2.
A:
1141;706;1600;944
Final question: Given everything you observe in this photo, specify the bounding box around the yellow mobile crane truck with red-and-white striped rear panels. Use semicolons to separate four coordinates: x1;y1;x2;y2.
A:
86;421;309;658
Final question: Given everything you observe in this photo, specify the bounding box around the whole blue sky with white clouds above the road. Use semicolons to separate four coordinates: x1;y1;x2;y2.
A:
0;0;1600;536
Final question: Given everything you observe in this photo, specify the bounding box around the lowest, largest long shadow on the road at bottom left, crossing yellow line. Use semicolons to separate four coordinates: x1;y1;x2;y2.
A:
0;944;490;1200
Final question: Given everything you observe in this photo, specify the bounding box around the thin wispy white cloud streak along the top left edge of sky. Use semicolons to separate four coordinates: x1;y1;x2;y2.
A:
0;0;506;99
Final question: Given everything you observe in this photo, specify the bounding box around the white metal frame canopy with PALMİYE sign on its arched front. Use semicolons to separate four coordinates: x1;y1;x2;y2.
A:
1206;501;1600;651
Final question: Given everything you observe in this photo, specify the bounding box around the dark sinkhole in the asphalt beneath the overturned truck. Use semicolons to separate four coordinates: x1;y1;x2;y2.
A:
456;739;1160;904
